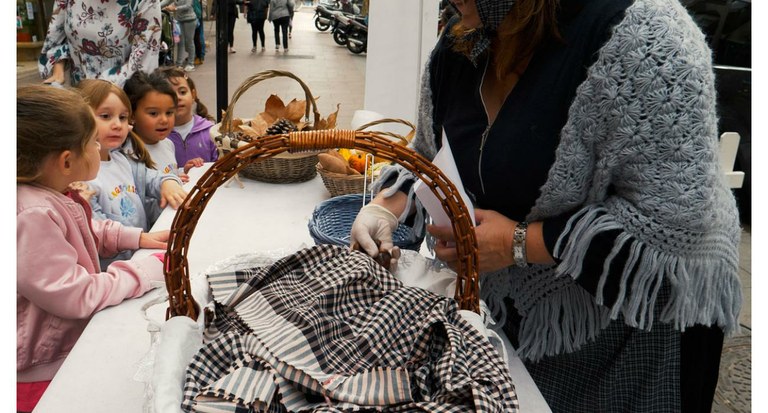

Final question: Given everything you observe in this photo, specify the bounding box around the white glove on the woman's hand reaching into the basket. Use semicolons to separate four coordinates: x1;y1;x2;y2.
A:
349;204;399;257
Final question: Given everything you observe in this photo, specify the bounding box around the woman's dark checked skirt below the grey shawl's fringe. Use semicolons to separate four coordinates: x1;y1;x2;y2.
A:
516;285;681;413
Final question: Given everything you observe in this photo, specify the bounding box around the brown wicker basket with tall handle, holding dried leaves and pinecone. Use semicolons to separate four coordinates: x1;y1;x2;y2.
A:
214;70;320;184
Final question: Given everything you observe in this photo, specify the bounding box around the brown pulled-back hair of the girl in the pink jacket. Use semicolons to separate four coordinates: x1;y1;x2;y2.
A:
16;85;96;182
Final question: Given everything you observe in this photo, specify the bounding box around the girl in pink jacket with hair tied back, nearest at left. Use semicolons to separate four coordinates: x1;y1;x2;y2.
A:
16;86;168;412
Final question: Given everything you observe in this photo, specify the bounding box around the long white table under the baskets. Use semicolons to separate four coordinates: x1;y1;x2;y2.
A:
35;166;550;413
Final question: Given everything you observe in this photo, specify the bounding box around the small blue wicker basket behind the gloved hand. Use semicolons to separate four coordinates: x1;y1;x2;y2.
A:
308;194;424;251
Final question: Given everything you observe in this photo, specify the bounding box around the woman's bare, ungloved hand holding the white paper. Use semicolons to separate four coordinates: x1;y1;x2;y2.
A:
427;209;517;273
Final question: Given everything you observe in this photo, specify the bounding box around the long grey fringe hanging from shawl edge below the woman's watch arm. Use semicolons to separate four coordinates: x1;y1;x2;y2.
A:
556;206;741;335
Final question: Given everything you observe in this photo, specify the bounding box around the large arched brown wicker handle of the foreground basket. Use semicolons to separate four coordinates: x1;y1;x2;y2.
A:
165;129;480;320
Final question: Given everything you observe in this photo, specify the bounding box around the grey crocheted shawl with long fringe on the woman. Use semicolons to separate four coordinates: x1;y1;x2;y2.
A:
374;0;741;360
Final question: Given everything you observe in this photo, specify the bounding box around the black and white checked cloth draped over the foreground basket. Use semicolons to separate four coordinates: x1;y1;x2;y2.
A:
182;245;518;412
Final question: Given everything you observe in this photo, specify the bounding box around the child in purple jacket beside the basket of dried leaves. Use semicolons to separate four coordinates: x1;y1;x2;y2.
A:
157;67;219;174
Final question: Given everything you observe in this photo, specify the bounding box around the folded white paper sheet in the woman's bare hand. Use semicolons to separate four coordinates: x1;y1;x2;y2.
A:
414;130;475;226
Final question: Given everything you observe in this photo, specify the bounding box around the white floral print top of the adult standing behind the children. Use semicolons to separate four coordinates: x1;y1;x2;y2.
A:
38;0;161;87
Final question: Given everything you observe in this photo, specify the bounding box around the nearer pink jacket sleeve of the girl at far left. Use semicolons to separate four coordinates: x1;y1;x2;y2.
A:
16;209;163;319
